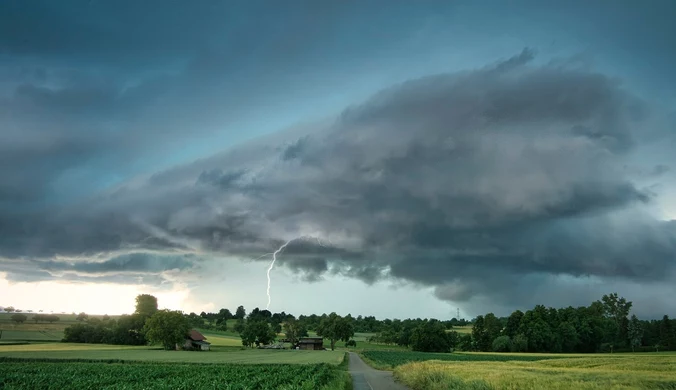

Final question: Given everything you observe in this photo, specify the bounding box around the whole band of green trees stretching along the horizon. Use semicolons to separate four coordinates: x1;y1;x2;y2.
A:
58;293;676;353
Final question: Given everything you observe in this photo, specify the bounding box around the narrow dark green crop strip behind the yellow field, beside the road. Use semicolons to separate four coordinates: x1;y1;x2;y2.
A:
362;350;558;367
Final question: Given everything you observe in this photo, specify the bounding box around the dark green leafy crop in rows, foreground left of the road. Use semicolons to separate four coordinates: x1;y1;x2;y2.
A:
0;362;344;390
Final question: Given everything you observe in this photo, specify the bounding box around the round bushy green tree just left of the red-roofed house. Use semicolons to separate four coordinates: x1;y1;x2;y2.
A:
143;310;190;350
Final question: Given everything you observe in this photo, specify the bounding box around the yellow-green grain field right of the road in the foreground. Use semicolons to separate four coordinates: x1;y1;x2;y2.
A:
394;353;676;390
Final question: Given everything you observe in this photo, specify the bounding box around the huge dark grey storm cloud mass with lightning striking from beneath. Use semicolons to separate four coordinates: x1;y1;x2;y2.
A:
0;50;676;316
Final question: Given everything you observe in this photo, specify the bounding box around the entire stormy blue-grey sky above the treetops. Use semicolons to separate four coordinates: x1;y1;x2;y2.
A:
0;0;676;319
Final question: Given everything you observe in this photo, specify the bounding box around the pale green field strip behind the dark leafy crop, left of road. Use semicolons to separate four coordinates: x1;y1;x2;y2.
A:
0;343;344;365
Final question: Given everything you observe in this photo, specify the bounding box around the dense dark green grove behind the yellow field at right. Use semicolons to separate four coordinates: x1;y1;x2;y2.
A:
468;293;676;353
